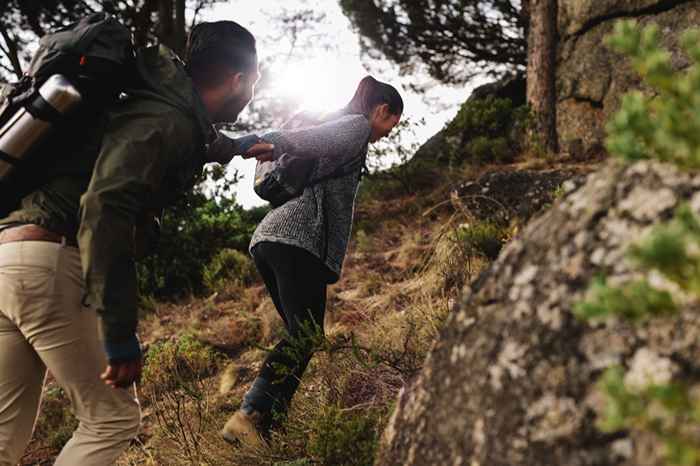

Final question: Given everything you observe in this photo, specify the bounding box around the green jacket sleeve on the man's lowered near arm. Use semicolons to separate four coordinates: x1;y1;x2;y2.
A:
78;107;192;342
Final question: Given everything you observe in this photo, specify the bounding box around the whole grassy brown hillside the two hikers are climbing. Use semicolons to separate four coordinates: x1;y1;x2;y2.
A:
23;143;591;465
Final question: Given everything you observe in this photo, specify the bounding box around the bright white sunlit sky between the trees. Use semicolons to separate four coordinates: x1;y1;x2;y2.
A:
201;0;478;208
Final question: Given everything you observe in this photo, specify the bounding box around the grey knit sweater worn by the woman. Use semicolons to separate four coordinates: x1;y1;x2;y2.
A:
250;115;371;283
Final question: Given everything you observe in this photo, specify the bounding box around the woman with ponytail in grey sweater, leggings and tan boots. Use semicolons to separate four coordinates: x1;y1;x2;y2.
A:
222;76;403;446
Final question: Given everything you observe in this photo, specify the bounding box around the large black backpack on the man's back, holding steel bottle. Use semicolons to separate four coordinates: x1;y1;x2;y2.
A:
0;13;137;218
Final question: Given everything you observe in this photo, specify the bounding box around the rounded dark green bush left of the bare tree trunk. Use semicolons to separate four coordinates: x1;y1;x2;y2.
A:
445;96;530;164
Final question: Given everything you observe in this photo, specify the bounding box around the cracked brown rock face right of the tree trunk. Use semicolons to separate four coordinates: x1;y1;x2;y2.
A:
556;0;700;159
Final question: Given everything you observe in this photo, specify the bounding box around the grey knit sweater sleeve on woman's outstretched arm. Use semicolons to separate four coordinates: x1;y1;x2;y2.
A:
262;115;371;178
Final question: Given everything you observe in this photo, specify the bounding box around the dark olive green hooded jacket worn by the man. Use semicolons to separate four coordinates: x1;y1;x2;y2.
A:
0;46;215;342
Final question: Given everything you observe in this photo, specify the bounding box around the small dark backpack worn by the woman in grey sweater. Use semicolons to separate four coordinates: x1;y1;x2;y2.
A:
253;113;367;207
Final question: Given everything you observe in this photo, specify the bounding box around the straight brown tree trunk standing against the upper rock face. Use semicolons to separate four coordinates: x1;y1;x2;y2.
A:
527;0;559;153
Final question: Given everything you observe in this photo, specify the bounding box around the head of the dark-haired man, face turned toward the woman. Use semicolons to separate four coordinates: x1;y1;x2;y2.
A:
185;21;260;122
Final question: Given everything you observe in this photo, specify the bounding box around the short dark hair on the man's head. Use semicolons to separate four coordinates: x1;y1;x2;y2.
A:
185;21;257;87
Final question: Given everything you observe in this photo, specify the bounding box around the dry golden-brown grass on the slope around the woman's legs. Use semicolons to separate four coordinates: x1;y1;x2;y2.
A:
24;163;516;466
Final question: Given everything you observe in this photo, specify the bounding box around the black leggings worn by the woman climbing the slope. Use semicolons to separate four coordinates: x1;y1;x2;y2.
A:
243;242;328;417
